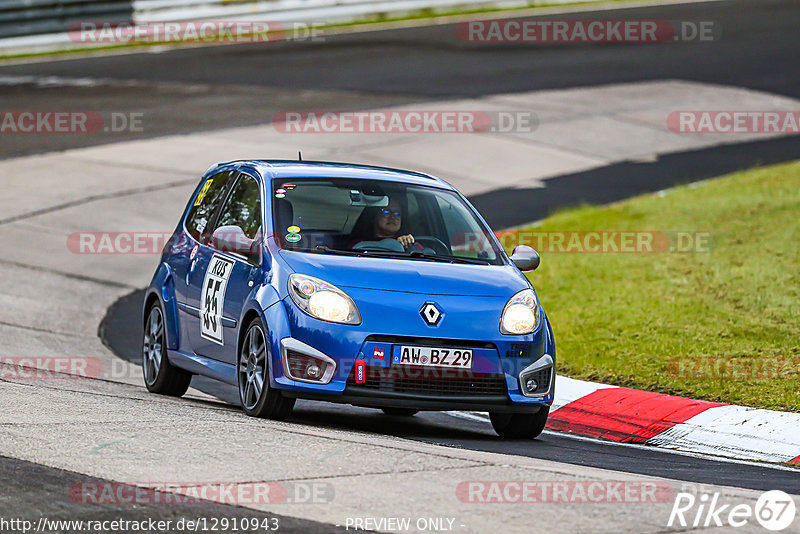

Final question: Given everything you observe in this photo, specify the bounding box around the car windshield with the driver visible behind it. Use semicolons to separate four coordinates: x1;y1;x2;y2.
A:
271;178;503;265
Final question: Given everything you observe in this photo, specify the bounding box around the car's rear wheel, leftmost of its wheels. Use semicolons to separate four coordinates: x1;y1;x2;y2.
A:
142;302;192;397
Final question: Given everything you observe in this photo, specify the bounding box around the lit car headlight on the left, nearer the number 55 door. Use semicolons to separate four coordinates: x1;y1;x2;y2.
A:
289;274;361;324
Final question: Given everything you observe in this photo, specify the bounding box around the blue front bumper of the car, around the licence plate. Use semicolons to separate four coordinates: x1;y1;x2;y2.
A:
265;288;555;413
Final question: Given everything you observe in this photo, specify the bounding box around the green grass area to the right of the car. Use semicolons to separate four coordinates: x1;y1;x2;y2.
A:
510;162;800;411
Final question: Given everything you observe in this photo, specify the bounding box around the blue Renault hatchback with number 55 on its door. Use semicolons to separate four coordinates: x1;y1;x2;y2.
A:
142;160;556;438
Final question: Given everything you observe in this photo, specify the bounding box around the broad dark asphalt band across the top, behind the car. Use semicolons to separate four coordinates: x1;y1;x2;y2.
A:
0;0;800;99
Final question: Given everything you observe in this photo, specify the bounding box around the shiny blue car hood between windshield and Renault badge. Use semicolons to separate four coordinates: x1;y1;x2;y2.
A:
280;250;529;297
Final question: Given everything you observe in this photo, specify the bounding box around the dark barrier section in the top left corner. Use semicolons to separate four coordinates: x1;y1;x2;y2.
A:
0;0;133;38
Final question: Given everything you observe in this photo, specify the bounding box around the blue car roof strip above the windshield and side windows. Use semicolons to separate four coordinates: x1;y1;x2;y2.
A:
209;160;453;189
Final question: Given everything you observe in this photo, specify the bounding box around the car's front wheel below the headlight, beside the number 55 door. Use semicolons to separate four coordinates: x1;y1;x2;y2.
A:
236;319;295;421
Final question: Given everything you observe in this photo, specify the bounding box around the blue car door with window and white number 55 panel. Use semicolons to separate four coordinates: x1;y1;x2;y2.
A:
187;173;263;365
